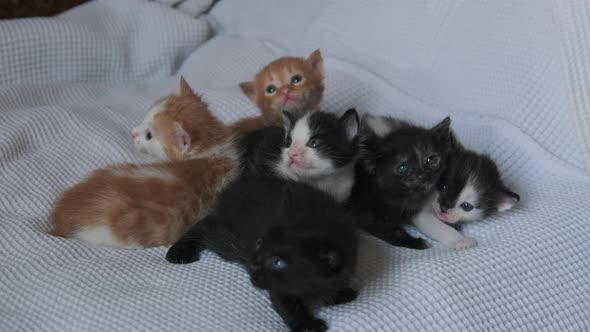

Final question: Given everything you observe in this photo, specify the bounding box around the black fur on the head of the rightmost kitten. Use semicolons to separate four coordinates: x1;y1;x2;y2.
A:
437;135;520;218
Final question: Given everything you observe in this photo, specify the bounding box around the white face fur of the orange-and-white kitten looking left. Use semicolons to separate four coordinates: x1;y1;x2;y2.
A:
131;100;168;159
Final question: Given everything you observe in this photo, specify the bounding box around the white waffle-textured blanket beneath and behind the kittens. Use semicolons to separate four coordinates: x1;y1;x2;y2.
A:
0;0;590;331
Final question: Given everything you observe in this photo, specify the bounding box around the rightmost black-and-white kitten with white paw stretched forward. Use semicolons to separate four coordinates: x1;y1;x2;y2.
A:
413;135;520;250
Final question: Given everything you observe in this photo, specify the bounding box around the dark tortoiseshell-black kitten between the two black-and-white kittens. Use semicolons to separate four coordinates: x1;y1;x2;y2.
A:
350;117;451;249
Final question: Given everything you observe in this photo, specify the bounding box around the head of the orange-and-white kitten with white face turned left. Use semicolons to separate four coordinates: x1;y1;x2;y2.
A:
131;77;231;160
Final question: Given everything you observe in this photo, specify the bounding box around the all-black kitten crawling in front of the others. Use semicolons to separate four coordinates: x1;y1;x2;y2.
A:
166;177;358;331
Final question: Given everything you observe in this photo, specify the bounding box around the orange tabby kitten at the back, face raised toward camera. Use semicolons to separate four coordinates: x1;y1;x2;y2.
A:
232;50;324;133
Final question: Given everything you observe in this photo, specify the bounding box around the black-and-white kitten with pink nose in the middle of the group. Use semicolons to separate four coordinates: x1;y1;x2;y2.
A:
241;109;359;202
